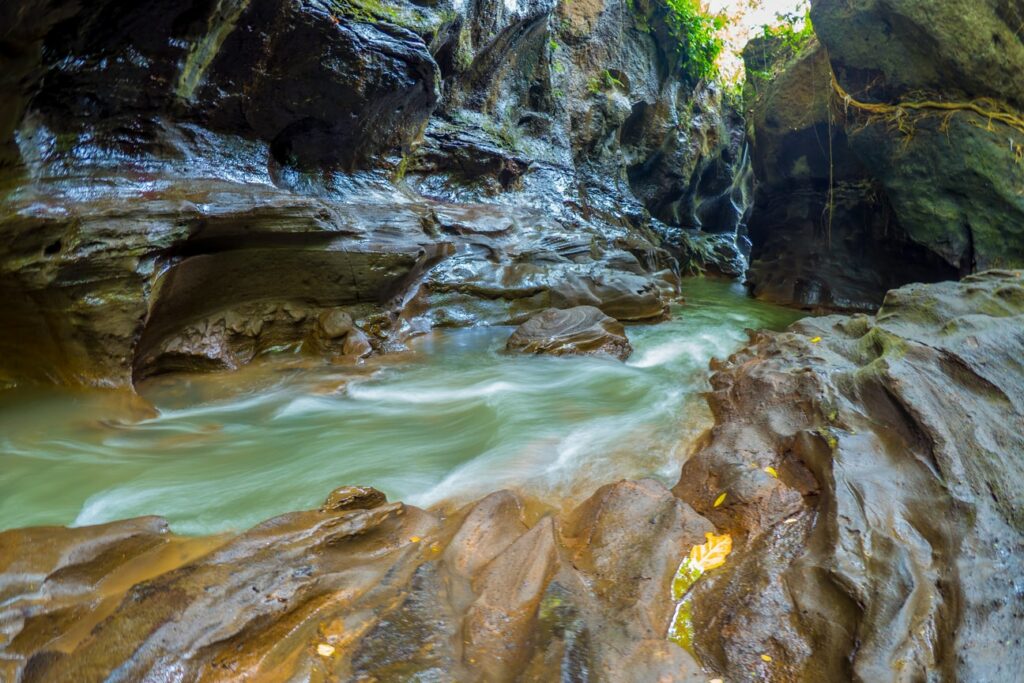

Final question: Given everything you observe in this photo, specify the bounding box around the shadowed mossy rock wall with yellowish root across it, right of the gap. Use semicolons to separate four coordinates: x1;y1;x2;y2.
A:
746;0;1024;310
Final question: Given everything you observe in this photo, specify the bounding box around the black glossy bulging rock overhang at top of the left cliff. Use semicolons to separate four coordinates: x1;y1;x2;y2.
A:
199;1;439;168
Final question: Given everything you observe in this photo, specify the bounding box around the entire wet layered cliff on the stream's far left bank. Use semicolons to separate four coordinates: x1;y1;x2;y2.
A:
0;0;745;385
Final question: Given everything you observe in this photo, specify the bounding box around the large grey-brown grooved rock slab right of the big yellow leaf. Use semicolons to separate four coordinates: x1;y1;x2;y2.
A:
675;271;1024;681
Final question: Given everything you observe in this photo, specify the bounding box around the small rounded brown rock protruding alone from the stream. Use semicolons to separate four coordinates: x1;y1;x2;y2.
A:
506;306;633;360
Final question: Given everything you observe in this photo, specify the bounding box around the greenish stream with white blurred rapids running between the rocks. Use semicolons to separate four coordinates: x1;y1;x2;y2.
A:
0;280;800;533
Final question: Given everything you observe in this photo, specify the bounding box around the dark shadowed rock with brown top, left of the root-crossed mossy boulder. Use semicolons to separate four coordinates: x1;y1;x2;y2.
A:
744;39;957;311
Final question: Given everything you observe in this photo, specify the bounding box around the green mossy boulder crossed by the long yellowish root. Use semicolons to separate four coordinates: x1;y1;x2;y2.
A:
812;0;1024;275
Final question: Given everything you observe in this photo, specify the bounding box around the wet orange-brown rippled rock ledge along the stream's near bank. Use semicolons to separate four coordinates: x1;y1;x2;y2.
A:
0;481;711;683
